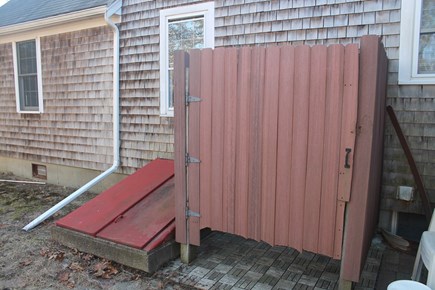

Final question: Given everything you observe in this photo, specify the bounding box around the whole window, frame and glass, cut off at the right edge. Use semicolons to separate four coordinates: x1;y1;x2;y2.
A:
399;0;435;84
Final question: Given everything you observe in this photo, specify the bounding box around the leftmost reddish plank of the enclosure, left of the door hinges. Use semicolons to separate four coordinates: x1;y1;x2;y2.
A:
174;51;188;244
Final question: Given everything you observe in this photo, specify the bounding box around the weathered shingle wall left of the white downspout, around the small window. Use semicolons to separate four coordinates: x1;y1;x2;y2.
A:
0;27;113;170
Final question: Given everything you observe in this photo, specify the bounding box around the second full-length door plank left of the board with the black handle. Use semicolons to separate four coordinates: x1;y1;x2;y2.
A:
303;46;327;252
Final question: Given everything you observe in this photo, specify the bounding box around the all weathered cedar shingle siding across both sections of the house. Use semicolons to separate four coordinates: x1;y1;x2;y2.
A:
0;0;435;216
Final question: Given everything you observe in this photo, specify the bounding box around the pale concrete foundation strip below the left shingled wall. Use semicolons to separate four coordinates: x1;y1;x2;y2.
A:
0;156;126;193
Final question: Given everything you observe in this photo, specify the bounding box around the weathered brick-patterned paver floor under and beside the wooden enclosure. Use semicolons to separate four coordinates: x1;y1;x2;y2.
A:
156;232;406;290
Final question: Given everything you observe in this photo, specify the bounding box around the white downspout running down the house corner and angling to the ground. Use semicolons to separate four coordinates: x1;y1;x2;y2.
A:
23;1;122;231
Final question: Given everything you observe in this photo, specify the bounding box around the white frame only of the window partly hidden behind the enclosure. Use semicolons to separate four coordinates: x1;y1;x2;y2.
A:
160;2;214;117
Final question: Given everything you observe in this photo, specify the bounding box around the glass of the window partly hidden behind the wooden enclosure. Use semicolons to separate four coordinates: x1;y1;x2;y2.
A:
168;17;204;108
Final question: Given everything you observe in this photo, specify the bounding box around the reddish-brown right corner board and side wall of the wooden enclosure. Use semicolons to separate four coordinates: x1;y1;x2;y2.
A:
340;36;387;281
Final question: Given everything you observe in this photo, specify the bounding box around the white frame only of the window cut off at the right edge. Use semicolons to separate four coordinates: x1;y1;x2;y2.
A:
399;0;435;85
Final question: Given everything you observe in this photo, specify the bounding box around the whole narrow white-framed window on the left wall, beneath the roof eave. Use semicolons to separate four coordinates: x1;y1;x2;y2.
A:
12;38;43;113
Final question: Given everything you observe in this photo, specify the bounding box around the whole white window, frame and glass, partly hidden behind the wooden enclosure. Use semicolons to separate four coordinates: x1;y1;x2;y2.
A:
160;2;214;117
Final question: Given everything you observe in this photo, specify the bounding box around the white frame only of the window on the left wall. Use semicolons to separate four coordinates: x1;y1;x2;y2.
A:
12;37;44;114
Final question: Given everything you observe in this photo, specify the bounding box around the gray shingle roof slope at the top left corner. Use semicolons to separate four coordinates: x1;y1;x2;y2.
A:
0;0;113;27
